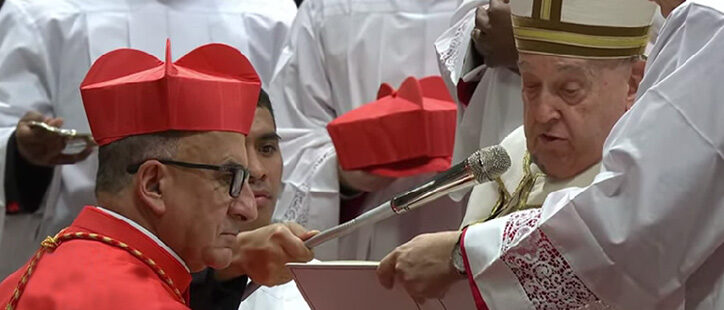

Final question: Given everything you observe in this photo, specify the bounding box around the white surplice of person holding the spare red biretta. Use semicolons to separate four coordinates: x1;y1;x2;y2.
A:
270;0;462;259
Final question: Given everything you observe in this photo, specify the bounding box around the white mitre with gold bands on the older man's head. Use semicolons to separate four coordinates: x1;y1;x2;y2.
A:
510;0;657;58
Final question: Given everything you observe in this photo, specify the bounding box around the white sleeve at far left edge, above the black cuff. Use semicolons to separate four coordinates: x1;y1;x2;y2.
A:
0;0;55;225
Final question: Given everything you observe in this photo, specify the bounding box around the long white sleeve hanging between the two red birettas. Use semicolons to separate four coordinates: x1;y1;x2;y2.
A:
269;2;339;258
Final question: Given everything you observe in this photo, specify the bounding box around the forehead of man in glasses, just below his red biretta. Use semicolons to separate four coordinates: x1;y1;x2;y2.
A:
178;131;246;164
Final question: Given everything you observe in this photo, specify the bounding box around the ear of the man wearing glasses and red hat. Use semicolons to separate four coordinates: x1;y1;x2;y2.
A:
134;160;170;216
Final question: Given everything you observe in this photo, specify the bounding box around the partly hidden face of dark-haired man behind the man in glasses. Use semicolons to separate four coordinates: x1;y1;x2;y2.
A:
242;108;283;231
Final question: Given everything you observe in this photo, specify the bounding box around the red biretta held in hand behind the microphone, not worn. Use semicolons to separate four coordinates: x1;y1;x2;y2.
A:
327;76;456;177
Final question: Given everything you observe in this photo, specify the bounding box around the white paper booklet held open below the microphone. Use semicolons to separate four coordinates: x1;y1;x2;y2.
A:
287;261;475;310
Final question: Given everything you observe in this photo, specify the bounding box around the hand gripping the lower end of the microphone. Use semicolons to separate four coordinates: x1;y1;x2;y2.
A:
216;222;319;286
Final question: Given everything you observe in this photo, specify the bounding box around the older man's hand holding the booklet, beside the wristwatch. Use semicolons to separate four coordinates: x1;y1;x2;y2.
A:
377;231;462;303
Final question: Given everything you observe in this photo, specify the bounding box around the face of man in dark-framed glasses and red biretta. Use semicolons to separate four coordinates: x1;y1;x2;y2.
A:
161;132;257;272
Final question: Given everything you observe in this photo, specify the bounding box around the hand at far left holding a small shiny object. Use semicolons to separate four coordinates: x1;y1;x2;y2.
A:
15;112;93;167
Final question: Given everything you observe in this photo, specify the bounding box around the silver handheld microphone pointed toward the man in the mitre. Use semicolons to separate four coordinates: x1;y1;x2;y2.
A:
304;145;510;249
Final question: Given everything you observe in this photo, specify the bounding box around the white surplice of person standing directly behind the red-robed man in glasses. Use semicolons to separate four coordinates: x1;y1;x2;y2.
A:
0;0;296;278
